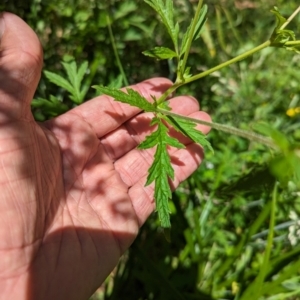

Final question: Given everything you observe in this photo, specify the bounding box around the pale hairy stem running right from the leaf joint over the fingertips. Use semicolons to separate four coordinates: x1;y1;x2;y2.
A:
157;108;278;149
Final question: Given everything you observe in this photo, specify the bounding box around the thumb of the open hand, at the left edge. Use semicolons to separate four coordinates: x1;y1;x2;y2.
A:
0;13;43;124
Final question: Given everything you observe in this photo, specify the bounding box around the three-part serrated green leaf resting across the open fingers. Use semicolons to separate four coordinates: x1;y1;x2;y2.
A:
95;82;212;228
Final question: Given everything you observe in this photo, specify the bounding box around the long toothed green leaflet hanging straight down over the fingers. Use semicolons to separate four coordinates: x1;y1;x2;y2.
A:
138;118;184;228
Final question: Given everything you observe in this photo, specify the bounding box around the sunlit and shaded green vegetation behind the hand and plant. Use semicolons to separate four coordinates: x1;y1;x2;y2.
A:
0;0;300;300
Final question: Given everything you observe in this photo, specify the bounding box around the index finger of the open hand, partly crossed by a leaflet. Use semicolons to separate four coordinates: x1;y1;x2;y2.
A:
67;78;172;138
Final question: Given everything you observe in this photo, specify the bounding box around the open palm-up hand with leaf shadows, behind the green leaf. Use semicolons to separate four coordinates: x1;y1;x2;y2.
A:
0;13;210;300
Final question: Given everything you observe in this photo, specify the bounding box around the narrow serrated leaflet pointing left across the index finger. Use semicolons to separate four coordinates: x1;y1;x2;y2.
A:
93;85;156;112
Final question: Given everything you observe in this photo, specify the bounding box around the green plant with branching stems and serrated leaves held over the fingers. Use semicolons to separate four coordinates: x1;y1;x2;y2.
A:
95;0;300;228
